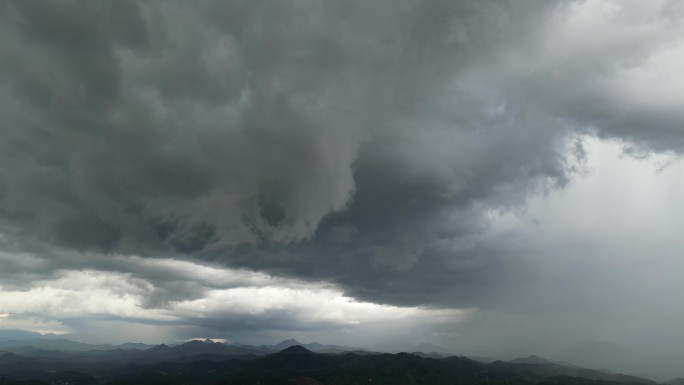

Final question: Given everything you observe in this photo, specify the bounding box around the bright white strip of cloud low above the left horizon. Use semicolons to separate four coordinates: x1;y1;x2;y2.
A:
0;256;467;342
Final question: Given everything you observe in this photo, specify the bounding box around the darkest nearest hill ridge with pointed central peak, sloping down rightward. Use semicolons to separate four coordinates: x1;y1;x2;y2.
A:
108;346;655;385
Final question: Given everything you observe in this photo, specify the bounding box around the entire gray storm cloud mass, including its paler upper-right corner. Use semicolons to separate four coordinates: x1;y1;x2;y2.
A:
0;0;684;376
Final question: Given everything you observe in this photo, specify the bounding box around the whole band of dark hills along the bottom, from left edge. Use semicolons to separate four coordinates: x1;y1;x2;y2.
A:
0;341;655;385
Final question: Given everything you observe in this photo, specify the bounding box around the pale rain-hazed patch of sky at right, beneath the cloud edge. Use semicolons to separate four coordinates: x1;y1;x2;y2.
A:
489;137;684;354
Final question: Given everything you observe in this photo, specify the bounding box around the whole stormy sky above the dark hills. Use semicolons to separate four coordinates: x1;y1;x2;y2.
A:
0;0;684;376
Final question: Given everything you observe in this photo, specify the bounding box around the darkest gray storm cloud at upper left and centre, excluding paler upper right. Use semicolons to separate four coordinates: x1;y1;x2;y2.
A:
0;1;568;301
